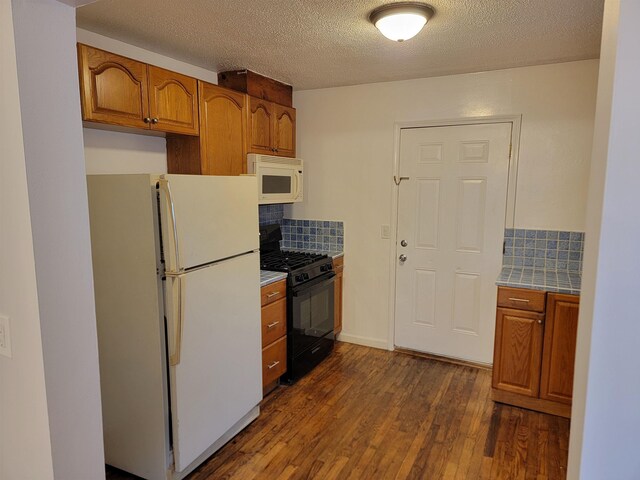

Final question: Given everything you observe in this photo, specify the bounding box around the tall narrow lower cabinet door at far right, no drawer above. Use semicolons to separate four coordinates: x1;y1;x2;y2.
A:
540;293;580;405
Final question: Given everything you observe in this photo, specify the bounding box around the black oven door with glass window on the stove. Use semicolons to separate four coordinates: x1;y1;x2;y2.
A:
289;272;335;357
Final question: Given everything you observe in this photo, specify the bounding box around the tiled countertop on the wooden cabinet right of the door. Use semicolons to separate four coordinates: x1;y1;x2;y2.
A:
496;266;582;295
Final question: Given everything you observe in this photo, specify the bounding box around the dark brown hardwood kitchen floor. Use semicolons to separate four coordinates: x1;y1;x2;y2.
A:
107;343;569;480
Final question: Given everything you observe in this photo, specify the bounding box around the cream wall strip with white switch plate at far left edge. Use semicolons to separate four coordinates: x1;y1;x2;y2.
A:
0;0;53;480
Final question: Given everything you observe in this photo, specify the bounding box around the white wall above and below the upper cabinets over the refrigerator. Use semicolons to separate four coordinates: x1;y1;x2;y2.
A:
77;28;218;174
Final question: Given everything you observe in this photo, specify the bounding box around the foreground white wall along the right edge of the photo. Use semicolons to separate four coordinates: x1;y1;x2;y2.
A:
568;0;640;480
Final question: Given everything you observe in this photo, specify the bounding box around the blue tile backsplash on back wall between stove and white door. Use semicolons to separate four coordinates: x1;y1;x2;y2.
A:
281;218;344;252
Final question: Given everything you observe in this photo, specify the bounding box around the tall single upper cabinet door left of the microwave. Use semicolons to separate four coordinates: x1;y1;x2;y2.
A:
200;82;247;175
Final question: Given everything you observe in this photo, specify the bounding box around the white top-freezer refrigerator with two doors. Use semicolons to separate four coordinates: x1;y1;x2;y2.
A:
87;175;262;480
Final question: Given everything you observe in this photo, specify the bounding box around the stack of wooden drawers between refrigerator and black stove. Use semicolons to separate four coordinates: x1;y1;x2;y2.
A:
260;280;287;395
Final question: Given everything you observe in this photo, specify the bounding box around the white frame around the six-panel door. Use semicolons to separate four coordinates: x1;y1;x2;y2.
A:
387;114;522;351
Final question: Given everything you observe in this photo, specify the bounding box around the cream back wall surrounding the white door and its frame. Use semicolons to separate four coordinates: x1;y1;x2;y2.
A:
288;60;598;346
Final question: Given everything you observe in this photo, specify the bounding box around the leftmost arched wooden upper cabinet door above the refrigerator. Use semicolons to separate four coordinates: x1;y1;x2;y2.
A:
78;44;149;128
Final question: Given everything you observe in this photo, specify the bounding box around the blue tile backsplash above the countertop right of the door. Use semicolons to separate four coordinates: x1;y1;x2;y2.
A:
502;228;584;272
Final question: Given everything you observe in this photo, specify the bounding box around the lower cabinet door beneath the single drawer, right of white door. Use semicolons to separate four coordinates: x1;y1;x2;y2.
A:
493;308;544;397
